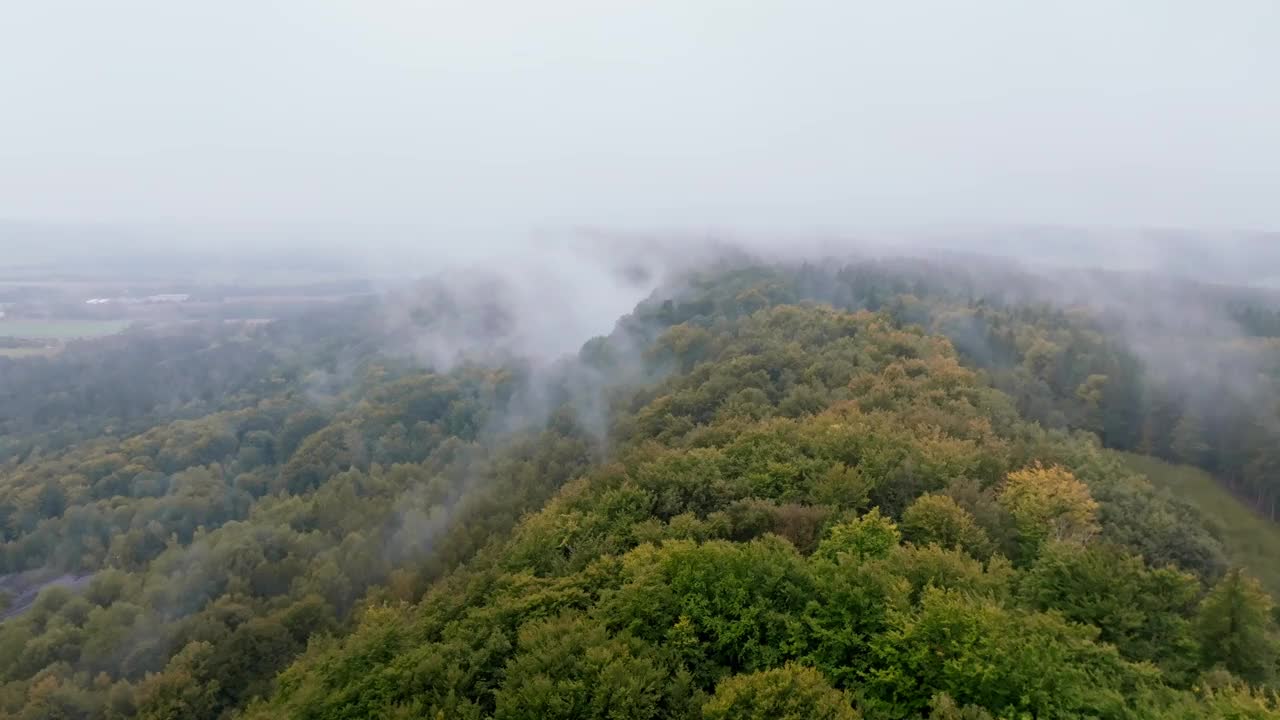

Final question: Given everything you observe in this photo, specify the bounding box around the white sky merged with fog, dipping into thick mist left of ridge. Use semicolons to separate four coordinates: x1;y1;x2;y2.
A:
0;0;1280;409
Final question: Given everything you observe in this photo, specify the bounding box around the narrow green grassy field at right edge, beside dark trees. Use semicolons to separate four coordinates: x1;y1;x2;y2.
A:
1121;454;1280;594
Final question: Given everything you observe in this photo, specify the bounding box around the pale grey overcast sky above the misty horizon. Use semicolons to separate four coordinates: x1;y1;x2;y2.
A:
0;0;1280;232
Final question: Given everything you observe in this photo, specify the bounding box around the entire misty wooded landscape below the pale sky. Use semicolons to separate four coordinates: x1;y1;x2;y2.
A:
0;229;1280;717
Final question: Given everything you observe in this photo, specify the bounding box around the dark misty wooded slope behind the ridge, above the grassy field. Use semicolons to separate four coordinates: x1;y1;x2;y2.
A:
658;256;1280;520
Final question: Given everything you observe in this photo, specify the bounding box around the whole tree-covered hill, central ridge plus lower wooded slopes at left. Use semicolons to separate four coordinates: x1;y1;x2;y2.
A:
0;261;1280;719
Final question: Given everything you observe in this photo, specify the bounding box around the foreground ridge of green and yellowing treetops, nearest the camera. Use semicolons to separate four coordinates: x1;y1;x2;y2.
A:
241;299;1276;719
